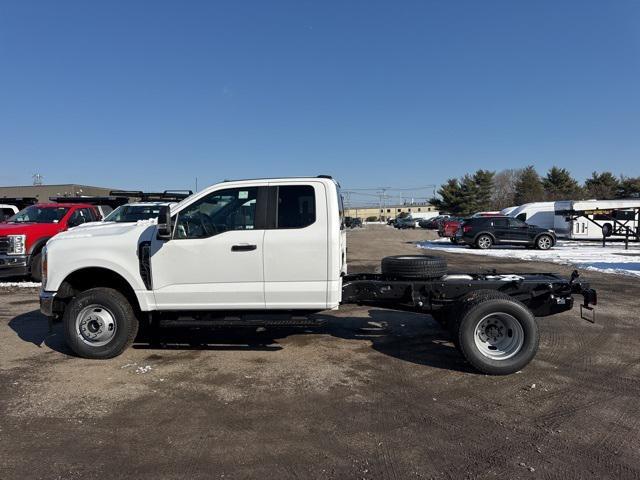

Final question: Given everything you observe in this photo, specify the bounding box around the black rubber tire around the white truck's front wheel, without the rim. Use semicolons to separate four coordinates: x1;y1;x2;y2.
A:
63;287;138;359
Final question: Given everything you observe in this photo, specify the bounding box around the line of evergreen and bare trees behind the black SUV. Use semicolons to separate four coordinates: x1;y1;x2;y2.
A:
431;165;640;216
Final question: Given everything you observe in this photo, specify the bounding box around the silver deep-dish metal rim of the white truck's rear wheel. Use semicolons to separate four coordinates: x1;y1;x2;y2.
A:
474;313;524;360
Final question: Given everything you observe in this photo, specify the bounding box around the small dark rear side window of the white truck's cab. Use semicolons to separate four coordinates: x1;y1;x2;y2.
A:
276;185;316;229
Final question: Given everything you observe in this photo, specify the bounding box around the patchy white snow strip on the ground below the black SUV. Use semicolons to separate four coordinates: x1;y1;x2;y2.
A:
418;238;640;278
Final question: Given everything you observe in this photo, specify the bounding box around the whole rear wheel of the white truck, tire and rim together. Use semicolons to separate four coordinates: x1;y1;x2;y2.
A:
455;291;540;375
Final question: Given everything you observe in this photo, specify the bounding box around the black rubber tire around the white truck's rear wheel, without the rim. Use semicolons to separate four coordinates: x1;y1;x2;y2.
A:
455;291;540;375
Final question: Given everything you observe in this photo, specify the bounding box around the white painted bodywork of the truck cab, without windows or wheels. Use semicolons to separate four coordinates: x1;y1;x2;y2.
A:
43;177;346;311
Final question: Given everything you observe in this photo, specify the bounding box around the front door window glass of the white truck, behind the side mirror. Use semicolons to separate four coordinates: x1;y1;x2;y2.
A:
174;187;258;238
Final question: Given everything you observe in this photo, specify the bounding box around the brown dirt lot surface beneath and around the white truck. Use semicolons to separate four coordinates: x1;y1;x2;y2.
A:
0;226;640;480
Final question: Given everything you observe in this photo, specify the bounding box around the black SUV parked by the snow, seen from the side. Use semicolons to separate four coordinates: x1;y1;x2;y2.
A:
456;216;556;250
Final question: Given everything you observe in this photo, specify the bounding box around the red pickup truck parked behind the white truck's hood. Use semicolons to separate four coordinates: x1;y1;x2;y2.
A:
0;203;101;281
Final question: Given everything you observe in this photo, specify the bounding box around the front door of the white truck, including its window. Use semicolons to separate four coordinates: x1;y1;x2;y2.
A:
151;185;267;310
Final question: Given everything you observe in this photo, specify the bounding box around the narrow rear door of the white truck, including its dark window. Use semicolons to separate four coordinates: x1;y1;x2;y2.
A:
264;182;329;309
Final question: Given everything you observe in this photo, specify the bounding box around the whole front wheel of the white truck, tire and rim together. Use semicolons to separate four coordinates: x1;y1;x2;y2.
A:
63;287;138;359
